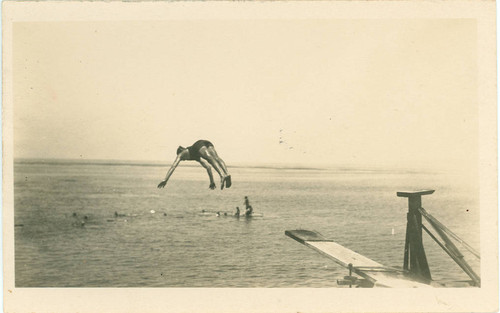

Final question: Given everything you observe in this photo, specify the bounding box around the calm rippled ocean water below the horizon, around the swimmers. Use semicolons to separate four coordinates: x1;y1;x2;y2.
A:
14;161;479;287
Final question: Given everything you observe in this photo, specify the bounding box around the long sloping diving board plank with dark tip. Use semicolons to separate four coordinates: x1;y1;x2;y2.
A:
285;229;431;288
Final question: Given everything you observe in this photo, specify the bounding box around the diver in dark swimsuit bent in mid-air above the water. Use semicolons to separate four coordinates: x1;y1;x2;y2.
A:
158;140;231;190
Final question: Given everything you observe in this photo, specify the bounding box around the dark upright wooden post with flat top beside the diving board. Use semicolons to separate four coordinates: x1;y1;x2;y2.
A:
397;190;434;283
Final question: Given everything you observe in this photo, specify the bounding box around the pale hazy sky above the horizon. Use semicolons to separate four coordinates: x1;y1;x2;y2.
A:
13;19;478;166
